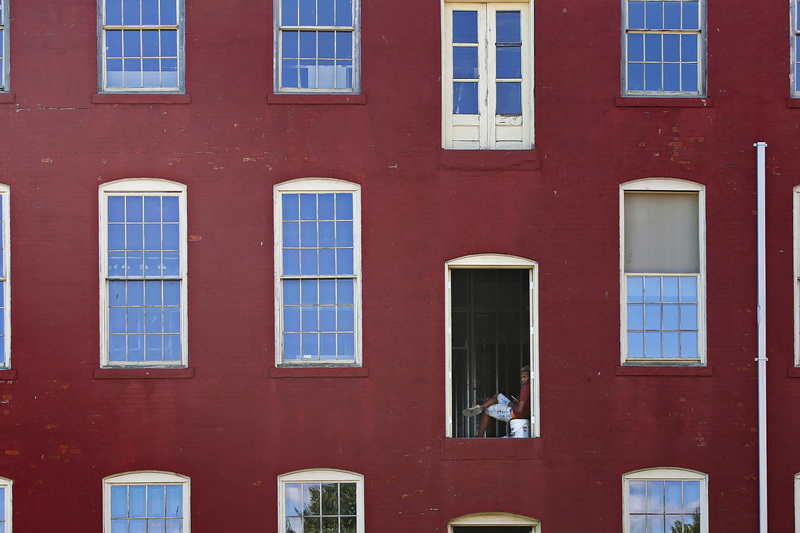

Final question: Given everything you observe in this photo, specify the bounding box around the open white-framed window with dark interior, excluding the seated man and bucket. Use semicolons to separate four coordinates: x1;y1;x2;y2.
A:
445;254;541;438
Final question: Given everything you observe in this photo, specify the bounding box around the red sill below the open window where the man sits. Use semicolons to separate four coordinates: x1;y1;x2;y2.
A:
442;437;545;461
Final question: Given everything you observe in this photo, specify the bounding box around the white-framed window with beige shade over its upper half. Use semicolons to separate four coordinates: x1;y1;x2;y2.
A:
620;178;706;364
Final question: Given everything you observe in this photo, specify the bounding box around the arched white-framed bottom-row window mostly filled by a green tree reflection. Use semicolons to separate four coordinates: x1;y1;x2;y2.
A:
278;468;364;533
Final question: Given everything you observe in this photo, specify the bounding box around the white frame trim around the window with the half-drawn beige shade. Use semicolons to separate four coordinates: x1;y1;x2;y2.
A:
618;178;707;365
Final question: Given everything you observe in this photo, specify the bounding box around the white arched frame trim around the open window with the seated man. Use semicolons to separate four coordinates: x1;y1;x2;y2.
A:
444;253;541;438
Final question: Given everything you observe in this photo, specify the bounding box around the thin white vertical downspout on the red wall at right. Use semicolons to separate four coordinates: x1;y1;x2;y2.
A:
753;142;767;533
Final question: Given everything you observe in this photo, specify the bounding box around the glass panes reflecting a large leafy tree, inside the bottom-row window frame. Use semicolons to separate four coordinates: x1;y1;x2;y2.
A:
285;482;357;533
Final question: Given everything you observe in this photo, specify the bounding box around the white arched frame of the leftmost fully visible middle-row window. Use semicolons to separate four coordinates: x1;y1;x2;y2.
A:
97;178;189;368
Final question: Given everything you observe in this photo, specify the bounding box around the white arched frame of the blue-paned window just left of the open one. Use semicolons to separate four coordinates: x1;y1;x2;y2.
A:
272;178;363;367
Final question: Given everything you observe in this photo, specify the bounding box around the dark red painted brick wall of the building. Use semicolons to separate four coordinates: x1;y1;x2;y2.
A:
0;0;800;533
